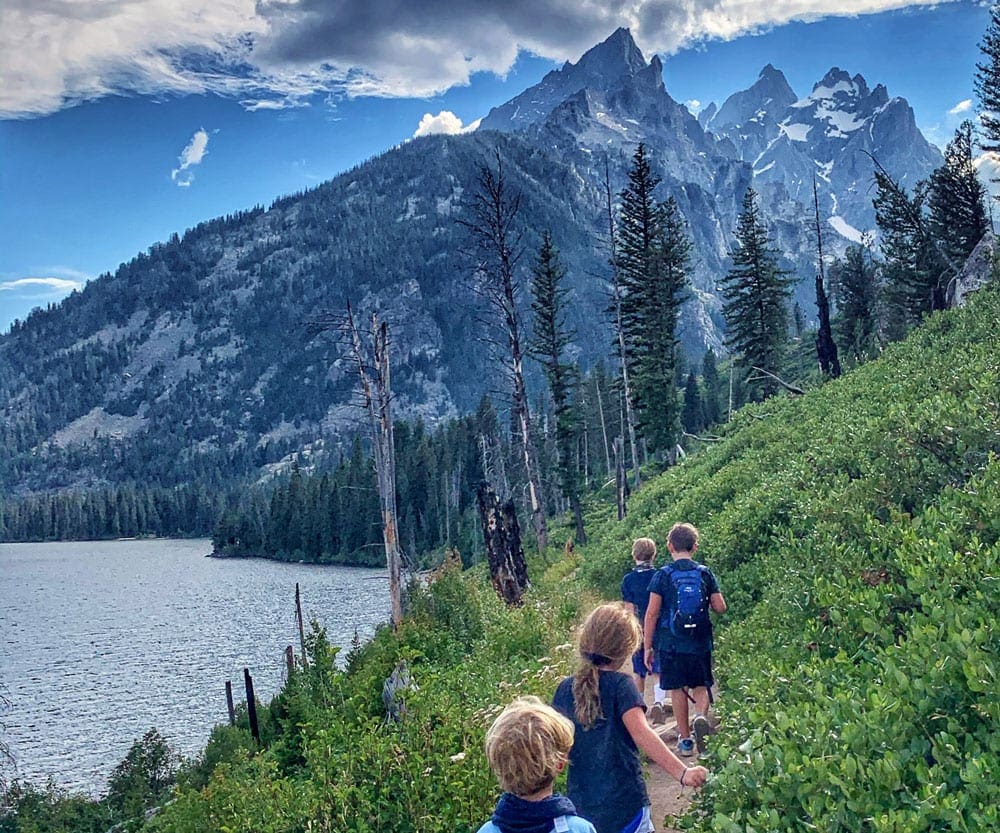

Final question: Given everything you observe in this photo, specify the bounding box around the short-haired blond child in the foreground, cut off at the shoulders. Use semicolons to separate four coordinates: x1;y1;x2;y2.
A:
479;697;594;833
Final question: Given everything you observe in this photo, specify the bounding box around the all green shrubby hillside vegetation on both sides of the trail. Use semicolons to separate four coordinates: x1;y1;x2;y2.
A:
9;293;1000;833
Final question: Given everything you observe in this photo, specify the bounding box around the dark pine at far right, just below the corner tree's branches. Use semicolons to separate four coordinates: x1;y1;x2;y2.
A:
927;121;988;268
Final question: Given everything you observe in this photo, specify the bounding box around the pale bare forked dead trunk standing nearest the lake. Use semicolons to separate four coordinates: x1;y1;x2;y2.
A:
347;304;403;628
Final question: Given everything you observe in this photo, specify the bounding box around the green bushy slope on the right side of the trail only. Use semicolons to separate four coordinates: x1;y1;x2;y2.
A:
582;294;1000;831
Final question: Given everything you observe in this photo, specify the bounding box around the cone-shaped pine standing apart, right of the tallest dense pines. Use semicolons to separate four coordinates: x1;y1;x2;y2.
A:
722;187;793;396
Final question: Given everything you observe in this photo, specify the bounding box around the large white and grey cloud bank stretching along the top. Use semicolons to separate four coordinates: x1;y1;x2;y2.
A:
0;0;964;118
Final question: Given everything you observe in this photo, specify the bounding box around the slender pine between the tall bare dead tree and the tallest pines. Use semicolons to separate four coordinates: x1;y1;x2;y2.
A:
528;231;587;544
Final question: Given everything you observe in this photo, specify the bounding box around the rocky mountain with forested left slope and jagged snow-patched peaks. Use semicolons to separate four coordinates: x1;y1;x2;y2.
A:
0;29;940;500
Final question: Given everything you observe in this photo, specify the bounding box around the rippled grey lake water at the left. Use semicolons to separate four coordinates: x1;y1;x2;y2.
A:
0;540;389;794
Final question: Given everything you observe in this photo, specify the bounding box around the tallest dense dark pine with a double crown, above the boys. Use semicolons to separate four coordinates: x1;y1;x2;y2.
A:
617;144;691;451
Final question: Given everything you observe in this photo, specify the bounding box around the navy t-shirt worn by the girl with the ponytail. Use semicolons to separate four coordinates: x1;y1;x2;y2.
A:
552;671;649;833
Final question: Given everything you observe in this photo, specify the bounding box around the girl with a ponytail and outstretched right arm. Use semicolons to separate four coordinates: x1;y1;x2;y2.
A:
552;602;708;833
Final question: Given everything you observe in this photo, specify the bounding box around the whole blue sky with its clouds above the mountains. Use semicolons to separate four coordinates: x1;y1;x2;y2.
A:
0;0;989;332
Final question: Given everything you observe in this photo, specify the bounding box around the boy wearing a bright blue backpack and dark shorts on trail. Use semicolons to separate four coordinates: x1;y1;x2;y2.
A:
643;523;726;757
